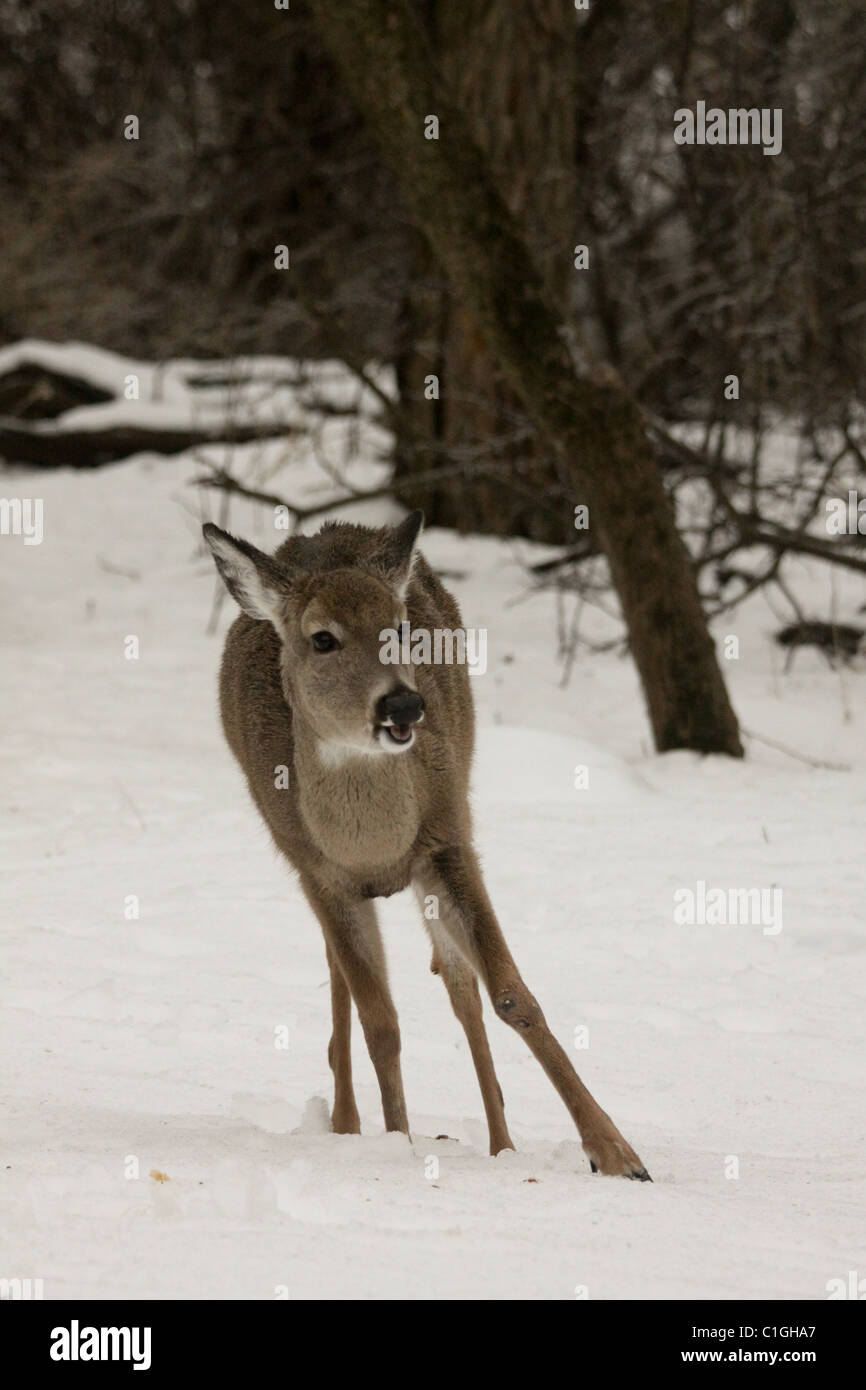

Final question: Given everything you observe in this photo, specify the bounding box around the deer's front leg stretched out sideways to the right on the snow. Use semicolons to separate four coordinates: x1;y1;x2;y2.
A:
422;847;651;1182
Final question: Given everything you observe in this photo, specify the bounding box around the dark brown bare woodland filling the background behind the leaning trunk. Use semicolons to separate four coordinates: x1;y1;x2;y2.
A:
0;0;866;472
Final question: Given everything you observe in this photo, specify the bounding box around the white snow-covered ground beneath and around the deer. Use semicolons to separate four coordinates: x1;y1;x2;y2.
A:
0;350;866;1300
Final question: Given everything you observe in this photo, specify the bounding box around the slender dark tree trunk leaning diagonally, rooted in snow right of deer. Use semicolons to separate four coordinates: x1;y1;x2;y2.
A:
311;0;742;756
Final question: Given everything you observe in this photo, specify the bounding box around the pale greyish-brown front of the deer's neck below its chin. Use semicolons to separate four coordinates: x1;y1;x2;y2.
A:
293;721;420;874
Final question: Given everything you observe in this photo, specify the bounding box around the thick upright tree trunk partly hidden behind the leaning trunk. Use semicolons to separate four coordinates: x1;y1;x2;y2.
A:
395;0;575;542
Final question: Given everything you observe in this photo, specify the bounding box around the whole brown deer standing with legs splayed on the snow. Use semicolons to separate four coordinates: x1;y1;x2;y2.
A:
203;512;651;1182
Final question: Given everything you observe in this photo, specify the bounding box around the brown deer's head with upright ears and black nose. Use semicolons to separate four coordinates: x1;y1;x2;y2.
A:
203;512;424;762
